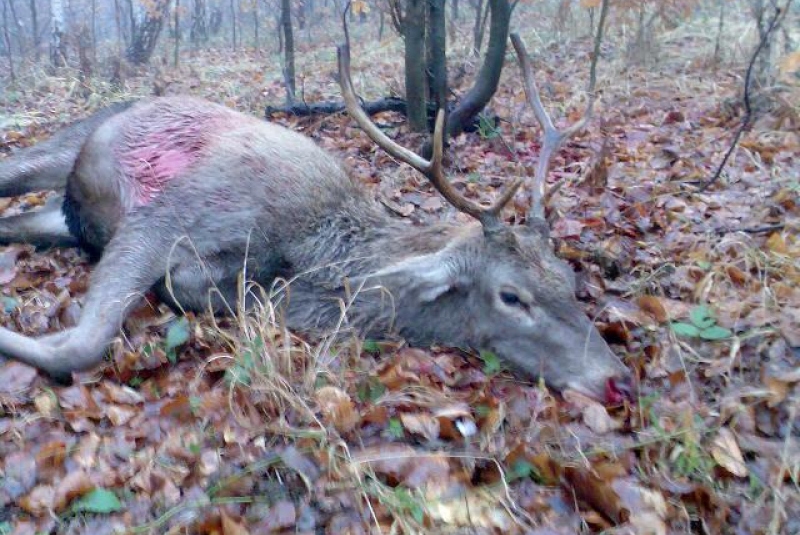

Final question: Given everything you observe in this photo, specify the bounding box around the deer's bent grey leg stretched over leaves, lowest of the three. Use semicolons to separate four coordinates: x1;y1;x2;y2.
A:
0;215;174;382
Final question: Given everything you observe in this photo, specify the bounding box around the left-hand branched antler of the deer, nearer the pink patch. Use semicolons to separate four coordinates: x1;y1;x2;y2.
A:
337;44;522;230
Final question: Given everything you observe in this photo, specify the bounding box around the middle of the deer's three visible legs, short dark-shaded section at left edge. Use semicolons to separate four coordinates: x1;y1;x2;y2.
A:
0;195;78;247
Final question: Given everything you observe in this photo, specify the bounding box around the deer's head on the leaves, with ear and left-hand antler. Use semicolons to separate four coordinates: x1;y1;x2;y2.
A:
338;45;630;400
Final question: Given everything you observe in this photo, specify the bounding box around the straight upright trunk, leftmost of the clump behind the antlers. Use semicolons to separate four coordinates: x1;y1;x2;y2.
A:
403;0;428;132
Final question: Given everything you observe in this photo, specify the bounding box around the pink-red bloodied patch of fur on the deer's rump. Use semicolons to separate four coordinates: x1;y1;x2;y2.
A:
117;108;219;206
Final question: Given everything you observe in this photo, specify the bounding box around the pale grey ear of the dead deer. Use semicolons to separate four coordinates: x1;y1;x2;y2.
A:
370;253;464;303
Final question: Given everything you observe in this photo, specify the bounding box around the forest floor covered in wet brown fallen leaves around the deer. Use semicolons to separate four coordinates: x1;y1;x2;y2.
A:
0;12;800;534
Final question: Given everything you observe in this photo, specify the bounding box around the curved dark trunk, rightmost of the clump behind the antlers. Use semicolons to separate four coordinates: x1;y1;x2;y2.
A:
447;0;511;137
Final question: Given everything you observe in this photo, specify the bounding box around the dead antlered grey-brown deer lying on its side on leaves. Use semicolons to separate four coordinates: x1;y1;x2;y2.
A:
0;51;629;399
